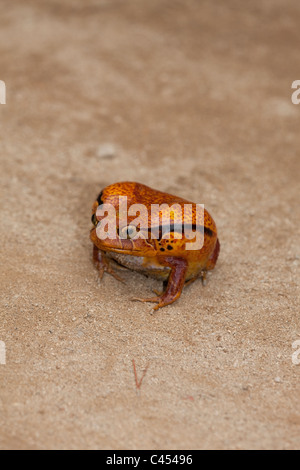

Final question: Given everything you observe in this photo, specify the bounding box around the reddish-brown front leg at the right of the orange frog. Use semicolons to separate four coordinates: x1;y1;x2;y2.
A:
133;257;188;310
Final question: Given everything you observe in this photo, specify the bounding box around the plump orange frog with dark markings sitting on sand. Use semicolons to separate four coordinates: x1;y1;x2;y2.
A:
90;181;220;311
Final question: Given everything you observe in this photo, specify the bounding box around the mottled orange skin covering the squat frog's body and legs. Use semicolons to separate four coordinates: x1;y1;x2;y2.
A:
91;182;220;310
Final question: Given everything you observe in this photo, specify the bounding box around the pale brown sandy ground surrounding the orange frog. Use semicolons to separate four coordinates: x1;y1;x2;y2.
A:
0;0;300;449
